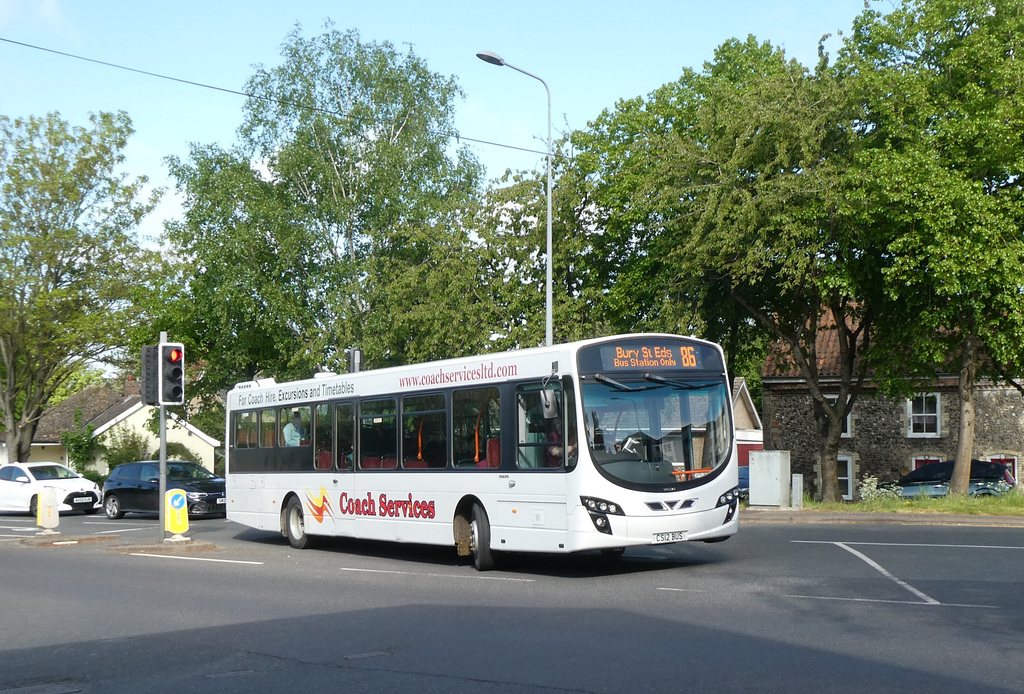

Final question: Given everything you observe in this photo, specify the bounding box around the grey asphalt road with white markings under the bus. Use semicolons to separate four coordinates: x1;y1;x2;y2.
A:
0;514;1024;694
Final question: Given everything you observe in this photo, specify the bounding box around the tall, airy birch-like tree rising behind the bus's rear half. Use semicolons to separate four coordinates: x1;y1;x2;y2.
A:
165;25;486;395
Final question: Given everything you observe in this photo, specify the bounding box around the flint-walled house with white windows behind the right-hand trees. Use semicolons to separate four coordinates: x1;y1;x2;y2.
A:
762;331;1024;500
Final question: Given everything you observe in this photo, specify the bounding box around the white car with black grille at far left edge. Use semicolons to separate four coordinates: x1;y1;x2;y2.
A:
0;463;103;515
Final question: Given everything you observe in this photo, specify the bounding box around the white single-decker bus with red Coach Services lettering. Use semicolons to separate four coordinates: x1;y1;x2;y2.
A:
226;335;738;570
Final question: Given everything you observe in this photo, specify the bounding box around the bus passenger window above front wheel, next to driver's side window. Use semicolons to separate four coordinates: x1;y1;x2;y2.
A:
452;388;502;470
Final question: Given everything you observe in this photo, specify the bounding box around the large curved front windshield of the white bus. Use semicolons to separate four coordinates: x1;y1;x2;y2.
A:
582;372;732;491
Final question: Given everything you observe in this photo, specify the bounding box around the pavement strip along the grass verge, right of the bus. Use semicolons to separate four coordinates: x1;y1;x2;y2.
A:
739;506;1024;528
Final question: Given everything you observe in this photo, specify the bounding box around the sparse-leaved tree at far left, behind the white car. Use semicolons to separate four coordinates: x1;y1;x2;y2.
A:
0;113;159;461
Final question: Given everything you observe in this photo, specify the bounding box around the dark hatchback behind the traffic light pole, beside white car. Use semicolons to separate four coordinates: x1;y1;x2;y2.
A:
103;461;227;519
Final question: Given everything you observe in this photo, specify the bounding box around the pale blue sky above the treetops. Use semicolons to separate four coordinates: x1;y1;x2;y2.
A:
0;0;864;233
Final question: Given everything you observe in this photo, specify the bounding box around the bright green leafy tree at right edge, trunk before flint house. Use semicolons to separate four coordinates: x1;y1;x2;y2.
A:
841;0;1024;493
